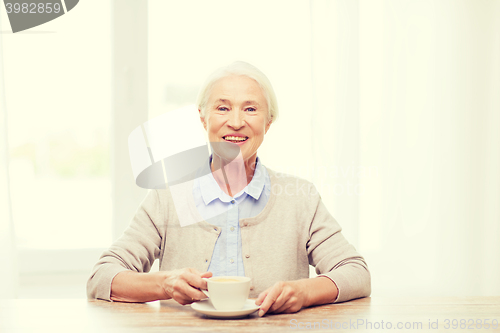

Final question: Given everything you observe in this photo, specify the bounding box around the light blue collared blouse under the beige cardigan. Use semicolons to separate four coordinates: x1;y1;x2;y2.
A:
193;157;271;276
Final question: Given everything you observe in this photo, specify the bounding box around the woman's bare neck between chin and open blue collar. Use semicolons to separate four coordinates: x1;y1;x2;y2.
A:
210;153;257;197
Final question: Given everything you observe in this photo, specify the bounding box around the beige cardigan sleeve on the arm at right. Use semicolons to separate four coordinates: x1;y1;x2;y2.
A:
307;192;371;303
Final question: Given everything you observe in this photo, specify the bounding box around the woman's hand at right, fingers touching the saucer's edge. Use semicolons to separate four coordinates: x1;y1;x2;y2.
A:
255;280;309;317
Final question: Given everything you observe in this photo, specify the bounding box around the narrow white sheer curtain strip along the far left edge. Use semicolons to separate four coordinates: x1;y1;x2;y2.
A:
0;23;18;299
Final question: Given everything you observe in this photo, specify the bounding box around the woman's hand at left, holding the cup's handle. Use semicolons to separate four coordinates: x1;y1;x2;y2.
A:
157;268;212;305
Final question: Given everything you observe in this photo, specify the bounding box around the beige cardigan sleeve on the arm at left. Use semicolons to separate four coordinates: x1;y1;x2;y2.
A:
87;190;162;301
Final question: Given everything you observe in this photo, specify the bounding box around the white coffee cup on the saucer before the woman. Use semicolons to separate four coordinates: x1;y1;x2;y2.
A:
202;276;251;310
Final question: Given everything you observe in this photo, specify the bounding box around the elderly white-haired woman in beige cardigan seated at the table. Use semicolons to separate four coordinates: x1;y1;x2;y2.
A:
87;62;370;316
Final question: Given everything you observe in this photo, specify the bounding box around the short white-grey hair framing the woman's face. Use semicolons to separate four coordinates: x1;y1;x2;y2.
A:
196;61;278;122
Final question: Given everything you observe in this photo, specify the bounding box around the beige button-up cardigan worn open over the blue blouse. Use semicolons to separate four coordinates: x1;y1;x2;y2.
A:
87;169;371;302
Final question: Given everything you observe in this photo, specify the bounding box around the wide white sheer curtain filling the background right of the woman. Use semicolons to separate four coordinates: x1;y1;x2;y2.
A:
310;0;500;296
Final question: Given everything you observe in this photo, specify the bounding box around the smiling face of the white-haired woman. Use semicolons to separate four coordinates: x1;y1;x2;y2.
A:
201;76;271;163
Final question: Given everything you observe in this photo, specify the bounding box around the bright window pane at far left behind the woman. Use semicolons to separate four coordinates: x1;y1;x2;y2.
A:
0;1;112;273
